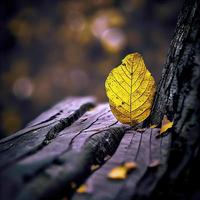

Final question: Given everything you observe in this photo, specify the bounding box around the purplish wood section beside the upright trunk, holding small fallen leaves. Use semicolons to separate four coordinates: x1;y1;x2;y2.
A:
72;129;170;200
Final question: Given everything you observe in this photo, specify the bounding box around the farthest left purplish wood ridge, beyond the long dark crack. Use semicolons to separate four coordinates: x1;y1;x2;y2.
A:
0;97;94;169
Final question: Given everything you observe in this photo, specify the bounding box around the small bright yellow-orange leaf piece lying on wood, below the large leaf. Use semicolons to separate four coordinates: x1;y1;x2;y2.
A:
108;166;127;180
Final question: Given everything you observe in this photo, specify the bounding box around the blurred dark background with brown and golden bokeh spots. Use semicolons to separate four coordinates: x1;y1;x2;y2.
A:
0;0;182;137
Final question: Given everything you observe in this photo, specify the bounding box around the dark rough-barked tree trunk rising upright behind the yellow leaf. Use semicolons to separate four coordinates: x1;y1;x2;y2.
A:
151;0;200;199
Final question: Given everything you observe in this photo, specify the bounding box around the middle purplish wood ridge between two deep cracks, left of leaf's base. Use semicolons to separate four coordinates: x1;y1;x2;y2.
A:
0;99;126;199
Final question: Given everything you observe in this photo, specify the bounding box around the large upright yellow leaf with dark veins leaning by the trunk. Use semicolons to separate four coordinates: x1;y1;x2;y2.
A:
105;53;156;125
